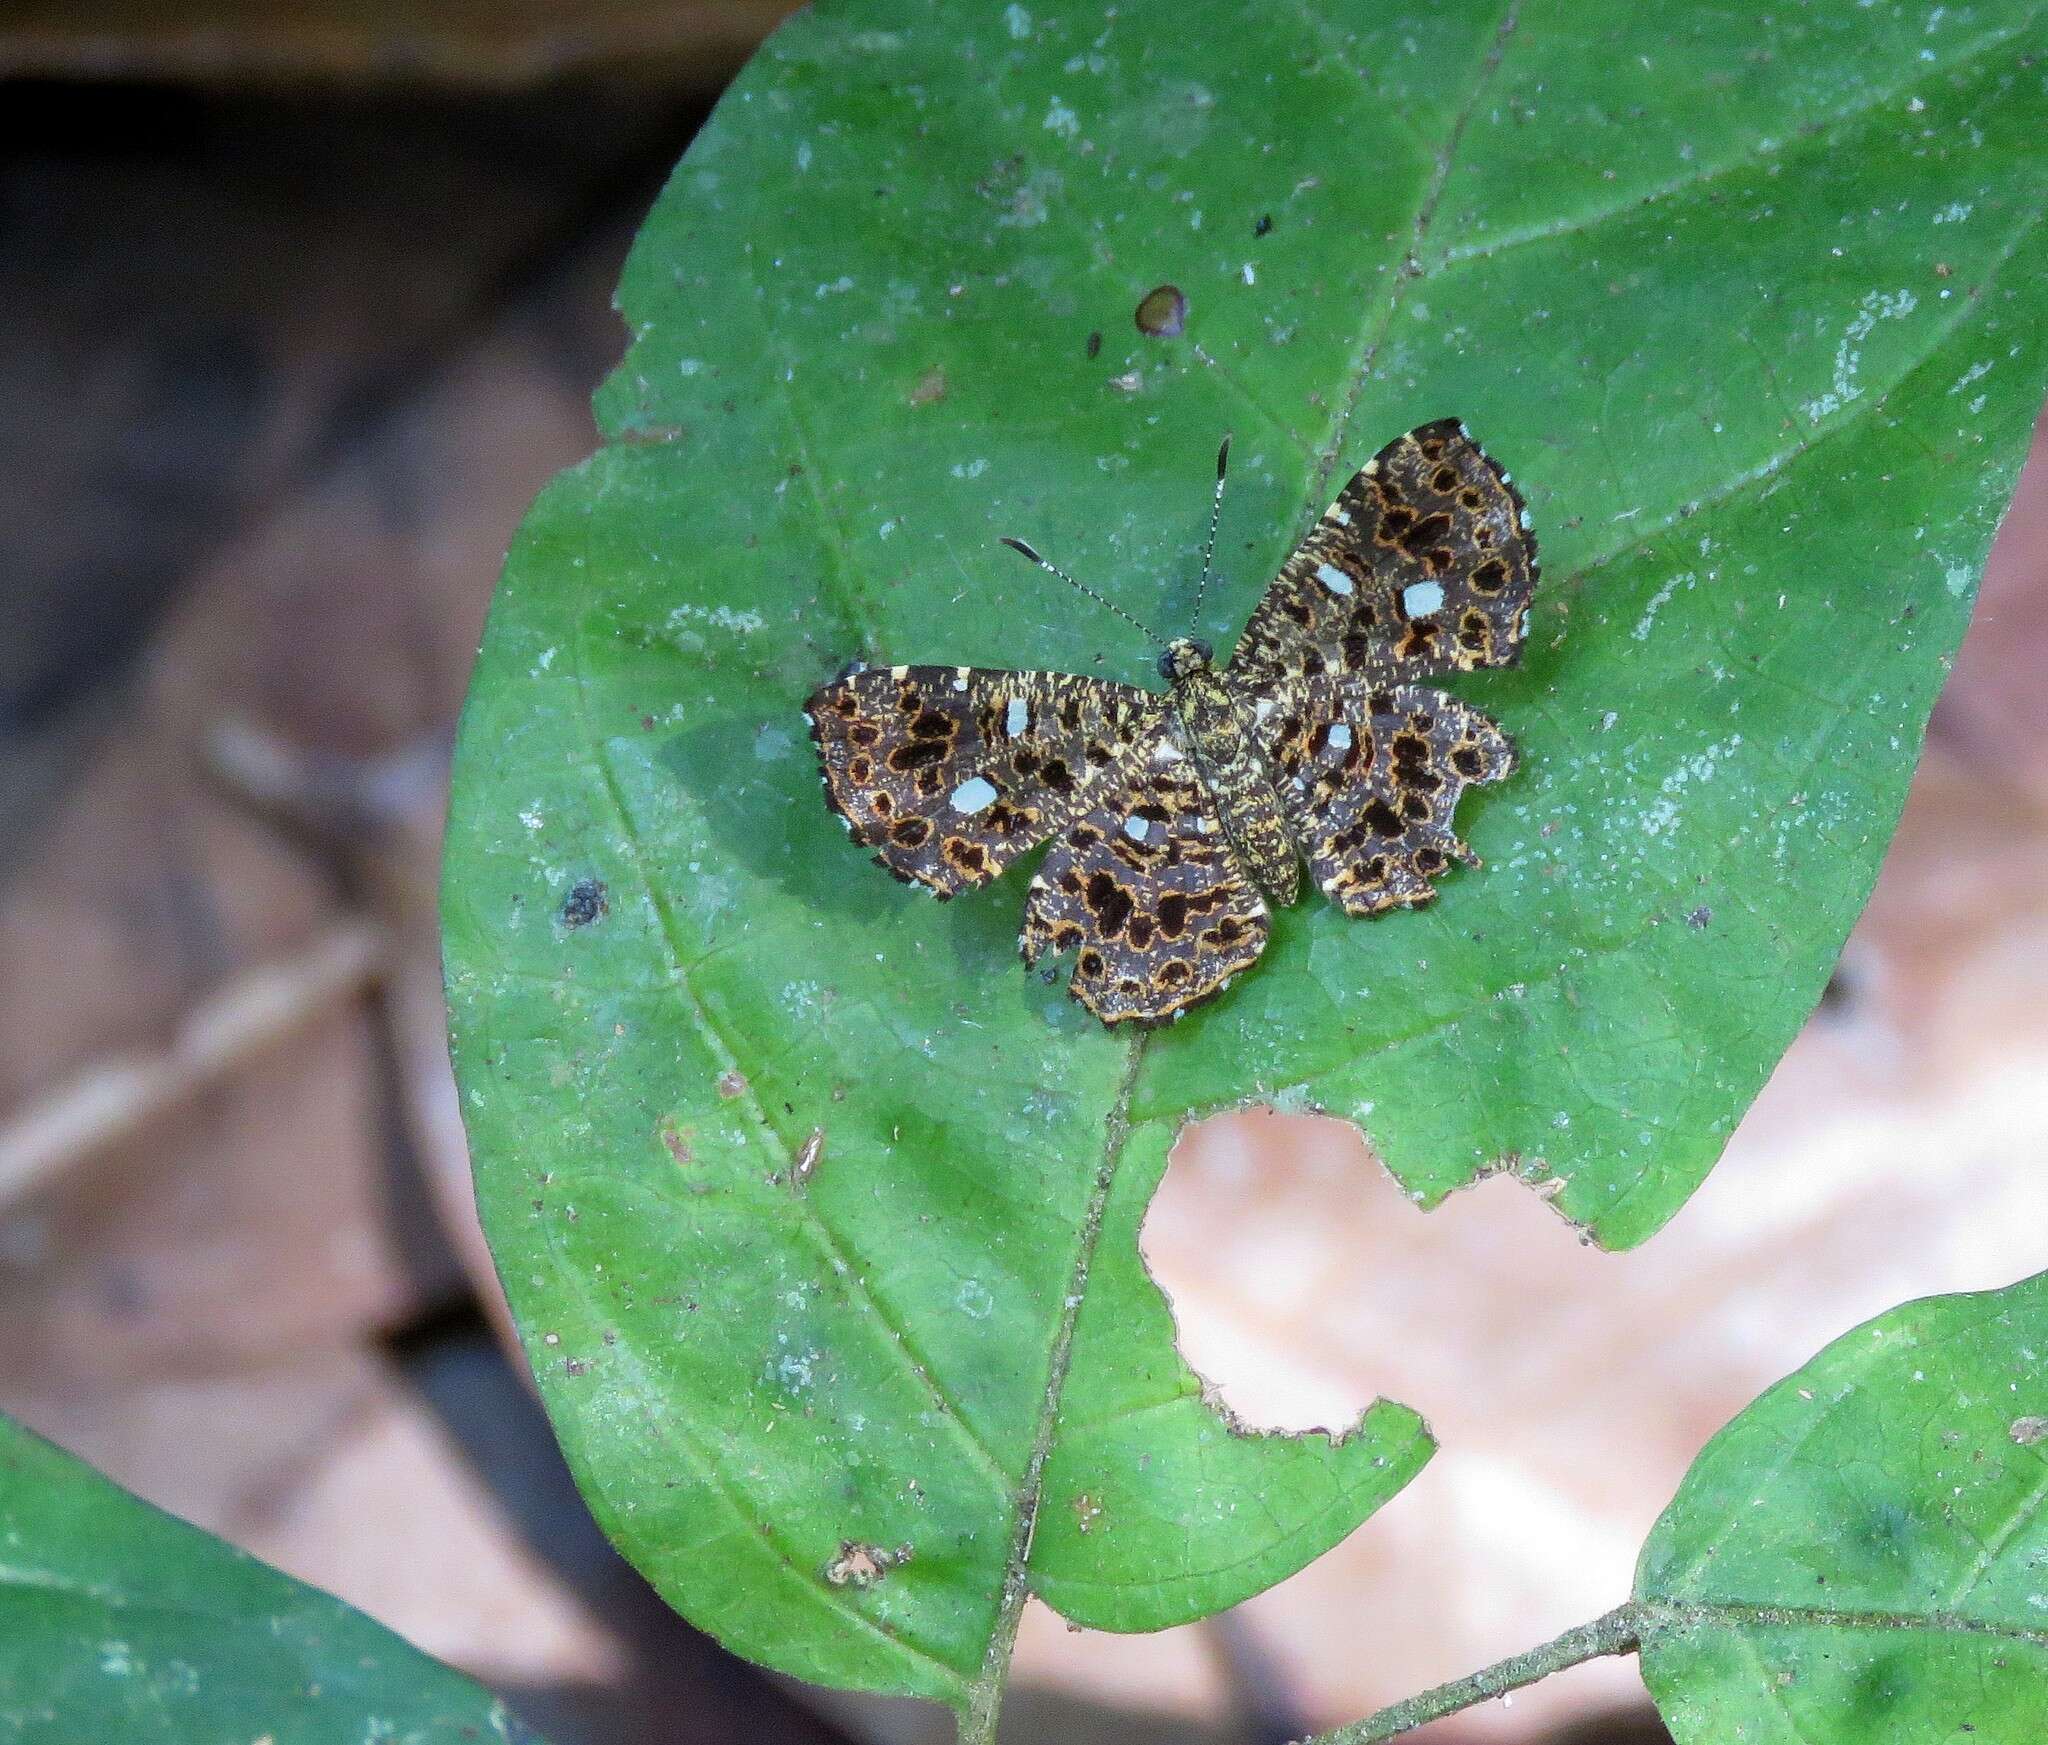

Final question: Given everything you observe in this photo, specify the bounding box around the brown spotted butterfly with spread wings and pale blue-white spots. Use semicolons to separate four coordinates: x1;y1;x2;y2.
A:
805;418;1536;1024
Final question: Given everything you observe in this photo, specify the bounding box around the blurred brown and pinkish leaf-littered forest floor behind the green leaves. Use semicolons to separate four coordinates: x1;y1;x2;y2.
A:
0;0;2048;1745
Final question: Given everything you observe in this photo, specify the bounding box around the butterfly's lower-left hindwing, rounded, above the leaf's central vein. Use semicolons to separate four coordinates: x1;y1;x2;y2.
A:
1022;729;1270;1024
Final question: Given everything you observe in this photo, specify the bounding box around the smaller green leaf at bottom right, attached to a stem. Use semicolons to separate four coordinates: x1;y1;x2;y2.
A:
1636;1274;2048;1745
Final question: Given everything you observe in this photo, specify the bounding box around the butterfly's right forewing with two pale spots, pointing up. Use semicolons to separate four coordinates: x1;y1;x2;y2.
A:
1231;418;1536;688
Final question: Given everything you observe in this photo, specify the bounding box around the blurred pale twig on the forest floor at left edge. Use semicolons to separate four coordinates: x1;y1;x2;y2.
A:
0;922;387;1206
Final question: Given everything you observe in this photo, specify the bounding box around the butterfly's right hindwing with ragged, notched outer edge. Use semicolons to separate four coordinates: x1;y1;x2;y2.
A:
1257;678;1516;916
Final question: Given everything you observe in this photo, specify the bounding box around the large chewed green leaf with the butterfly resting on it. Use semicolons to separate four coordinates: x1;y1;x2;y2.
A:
444;0;2048;1710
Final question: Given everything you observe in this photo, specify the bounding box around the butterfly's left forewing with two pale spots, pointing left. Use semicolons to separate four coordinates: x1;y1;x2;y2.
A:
805;666;1163;897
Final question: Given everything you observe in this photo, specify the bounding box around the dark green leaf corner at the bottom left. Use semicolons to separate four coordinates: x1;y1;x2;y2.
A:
0;1417;539;1745
